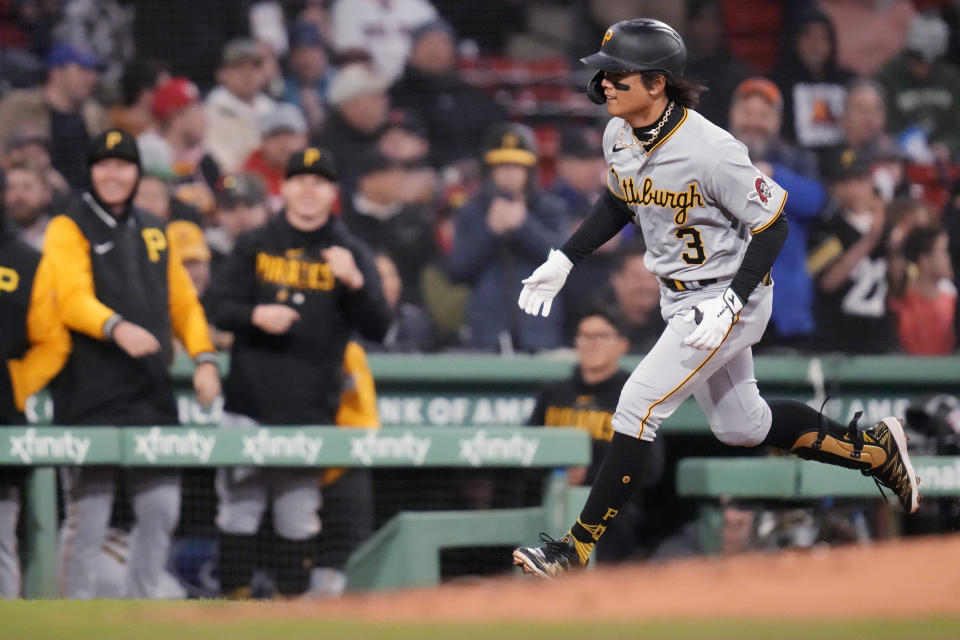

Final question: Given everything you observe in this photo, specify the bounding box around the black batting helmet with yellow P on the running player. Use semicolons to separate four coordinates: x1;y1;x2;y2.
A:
580;18;687;104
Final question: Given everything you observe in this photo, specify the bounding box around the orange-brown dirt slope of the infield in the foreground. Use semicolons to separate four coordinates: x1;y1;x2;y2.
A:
270;535;960;622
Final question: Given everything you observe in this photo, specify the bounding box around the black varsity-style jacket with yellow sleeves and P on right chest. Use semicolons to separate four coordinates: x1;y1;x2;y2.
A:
44;193;214;425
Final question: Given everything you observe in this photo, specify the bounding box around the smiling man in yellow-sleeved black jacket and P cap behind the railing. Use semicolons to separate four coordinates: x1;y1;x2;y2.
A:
43;129;220;599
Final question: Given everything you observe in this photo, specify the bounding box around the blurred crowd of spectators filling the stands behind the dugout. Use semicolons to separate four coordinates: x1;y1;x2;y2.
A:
0;0;960;596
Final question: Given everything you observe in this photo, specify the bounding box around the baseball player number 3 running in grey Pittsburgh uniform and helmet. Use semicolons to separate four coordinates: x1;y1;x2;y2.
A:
513;18;920;577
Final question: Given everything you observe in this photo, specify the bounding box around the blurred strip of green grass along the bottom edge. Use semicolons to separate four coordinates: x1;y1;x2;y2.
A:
0;601;960;640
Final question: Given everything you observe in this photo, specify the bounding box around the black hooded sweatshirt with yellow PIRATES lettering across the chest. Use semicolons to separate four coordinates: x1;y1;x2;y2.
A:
204;212;390;424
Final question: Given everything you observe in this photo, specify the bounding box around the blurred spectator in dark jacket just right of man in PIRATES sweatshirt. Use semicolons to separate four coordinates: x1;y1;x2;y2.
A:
364;253;437;353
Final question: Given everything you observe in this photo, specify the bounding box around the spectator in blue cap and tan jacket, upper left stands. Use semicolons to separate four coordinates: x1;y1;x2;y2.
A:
0;44;106;189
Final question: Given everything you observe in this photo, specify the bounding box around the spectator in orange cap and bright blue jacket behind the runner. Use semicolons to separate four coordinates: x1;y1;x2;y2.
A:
730;77;827;348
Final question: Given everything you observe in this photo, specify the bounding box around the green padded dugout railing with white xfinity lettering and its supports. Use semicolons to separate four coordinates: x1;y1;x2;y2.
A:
7;426;590;598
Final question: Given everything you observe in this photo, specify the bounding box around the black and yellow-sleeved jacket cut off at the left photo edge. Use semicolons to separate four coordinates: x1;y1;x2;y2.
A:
0;220;70;424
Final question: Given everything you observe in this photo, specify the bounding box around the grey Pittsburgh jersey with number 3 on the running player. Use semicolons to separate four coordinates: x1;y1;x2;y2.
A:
603;107;787;280
